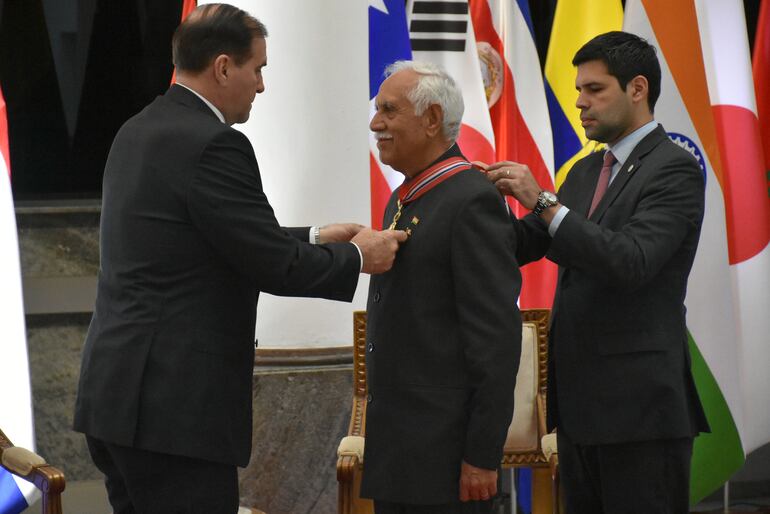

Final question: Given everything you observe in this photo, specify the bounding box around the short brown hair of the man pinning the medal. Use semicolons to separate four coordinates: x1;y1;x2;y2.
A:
171;4;267;75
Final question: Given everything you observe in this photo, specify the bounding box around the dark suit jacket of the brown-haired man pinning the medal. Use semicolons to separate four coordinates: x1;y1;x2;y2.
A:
74;86;360;466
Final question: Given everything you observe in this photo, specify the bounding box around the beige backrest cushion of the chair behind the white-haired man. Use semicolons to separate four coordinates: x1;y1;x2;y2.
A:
505;322;540;453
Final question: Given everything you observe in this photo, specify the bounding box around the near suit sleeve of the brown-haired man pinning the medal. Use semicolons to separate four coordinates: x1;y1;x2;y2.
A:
187;126;360;301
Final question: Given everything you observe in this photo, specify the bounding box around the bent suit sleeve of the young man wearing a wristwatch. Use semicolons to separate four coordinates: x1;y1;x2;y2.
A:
548;152;705;291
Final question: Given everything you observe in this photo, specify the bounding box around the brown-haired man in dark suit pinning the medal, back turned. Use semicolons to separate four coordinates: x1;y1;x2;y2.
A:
74;4;406;514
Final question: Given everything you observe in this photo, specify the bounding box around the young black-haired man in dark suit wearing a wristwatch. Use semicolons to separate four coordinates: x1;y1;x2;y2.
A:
488;32;709;514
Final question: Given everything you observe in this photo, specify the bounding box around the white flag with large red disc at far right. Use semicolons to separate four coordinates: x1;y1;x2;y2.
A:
695;0;770;492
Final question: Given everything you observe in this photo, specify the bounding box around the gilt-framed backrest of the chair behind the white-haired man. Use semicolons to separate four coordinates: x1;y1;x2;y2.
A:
348;309;550;467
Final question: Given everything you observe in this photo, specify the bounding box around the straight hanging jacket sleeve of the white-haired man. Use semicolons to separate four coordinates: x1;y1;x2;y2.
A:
451;189;521;469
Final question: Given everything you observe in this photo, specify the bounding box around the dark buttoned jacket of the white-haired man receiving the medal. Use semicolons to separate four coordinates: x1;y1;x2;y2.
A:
361;147;521;504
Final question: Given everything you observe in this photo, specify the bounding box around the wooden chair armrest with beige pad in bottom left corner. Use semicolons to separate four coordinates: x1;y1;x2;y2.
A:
0;430;64;514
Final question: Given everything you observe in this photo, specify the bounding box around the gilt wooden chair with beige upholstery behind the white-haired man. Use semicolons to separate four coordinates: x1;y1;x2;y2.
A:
337;309;553;514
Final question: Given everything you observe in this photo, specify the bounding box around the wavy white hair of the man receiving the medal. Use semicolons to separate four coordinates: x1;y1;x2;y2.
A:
385;61;465;142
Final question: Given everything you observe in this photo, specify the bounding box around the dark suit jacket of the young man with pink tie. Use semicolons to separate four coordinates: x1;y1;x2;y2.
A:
515;126;708;444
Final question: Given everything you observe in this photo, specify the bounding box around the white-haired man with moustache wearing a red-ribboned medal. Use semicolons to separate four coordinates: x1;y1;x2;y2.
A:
361;62;521;514
